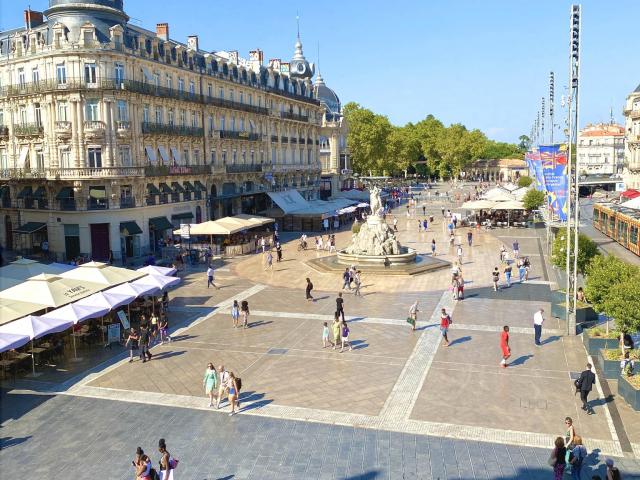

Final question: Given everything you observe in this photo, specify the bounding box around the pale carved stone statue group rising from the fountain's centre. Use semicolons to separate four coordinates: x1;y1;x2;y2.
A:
344;186;406;257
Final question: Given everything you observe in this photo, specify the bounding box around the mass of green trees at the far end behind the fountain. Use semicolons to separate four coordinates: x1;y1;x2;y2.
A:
344;102;522;177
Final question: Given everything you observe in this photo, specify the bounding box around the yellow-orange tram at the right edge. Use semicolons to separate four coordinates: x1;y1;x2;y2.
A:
593;203;640;255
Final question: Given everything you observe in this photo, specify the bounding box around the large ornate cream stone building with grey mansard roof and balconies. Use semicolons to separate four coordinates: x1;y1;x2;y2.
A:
0;0;325;261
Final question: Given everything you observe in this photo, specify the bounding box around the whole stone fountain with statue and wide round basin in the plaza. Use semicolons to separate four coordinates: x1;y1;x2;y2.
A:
308;186;450;275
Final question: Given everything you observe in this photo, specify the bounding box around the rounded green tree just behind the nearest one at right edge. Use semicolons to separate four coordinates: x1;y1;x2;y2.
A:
584;255;640;317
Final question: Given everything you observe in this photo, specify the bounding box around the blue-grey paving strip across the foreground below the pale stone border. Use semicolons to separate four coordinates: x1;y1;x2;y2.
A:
0;392;640;480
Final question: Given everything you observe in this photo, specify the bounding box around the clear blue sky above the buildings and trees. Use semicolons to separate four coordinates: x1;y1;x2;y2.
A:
0;0;640;142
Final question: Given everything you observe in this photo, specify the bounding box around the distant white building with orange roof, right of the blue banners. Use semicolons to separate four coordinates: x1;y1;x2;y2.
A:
576;123;625;175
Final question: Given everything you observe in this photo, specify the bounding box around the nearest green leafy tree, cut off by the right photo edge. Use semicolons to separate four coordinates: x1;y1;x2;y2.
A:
603;273;640;333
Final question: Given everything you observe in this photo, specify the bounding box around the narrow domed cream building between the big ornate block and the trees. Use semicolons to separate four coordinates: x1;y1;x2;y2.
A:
313;73;353;200
